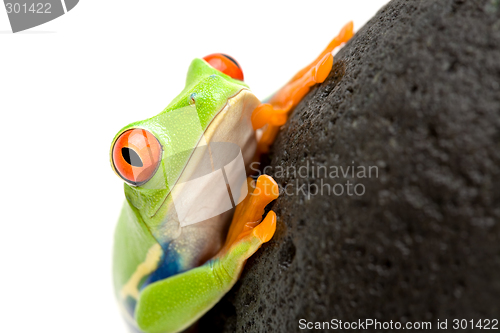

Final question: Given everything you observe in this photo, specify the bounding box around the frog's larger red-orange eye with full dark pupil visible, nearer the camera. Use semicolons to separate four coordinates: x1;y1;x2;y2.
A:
112;128;162;185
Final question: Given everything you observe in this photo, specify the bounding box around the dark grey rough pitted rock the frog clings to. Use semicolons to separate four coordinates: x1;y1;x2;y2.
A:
199;0;500;332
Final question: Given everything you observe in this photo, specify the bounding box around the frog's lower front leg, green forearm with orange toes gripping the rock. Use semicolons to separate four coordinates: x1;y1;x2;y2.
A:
135;175;278;333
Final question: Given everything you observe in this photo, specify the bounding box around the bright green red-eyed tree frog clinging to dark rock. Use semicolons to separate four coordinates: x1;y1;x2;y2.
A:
110;22;353;333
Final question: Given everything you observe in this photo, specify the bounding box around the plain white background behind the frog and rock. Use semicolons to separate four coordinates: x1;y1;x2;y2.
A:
0;0;387;333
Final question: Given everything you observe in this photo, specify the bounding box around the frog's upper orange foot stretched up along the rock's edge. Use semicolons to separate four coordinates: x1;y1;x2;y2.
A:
252;22;354;152
